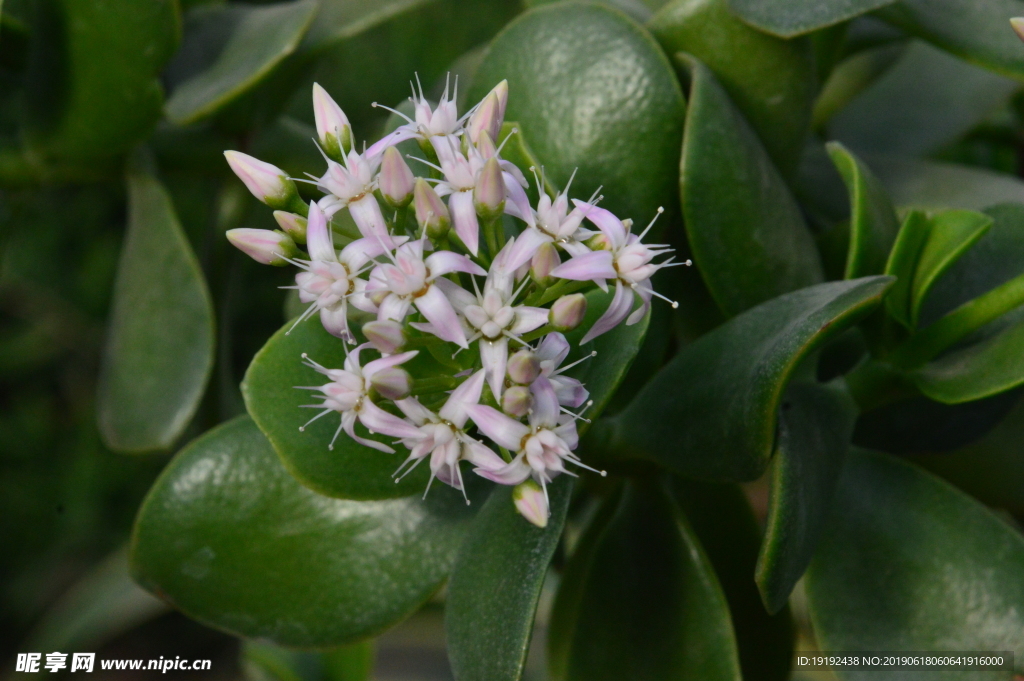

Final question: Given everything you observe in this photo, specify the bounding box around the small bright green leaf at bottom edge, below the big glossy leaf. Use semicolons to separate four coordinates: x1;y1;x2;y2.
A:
242;641;374;681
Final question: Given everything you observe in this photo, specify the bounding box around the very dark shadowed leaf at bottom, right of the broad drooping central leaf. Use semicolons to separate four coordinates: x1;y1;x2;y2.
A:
672;477;796;681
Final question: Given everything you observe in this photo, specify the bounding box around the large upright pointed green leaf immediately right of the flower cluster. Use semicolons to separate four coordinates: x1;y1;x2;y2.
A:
679;57;822;315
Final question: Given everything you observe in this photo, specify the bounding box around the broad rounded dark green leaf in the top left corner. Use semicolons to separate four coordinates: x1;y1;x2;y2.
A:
22;0;181;165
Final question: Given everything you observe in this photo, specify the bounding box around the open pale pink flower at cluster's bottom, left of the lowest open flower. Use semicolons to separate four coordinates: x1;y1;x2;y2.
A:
394;371;505;504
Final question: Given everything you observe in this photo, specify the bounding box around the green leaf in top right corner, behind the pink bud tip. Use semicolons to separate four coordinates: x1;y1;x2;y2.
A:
877;0;1024;80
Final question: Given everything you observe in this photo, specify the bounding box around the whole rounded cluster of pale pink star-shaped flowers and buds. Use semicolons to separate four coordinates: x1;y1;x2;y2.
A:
225;82;674;526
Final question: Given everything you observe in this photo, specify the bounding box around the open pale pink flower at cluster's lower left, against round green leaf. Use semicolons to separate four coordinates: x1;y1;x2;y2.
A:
299;343;419;454
